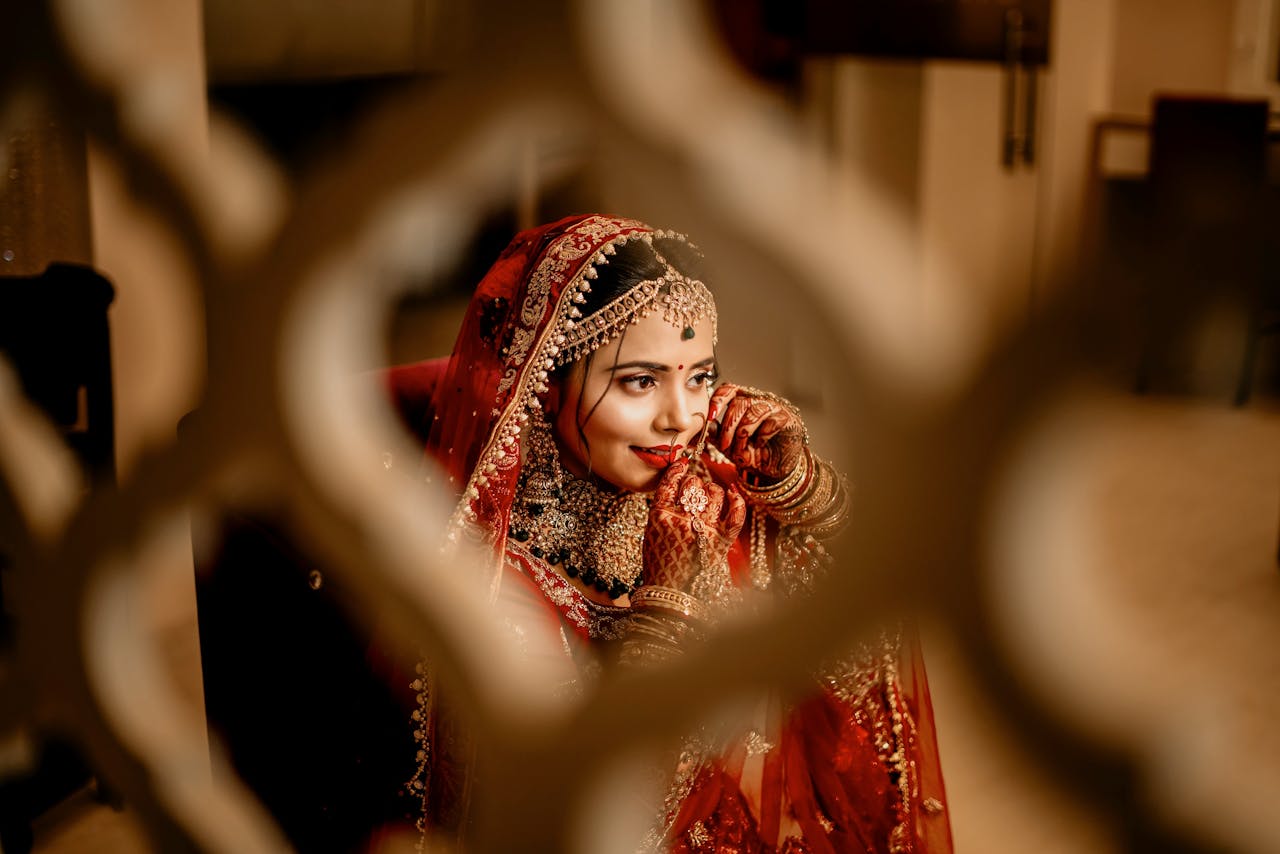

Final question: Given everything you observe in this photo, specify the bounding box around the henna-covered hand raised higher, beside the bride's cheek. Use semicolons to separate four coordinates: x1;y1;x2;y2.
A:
709;383;805;480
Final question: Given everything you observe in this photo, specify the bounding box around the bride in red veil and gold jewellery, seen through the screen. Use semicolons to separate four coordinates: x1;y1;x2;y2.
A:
393;215;951;853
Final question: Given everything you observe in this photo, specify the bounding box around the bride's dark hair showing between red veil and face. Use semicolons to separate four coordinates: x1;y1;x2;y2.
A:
553;237;703;470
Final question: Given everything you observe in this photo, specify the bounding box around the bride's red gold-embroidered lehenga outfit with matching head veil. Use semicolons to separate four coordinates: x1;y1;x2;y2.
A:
390;215;951;853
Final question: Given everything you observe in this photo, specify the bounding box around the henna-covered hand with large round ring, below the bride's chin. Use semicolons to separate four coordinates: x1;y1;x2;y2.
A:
643;460;746;590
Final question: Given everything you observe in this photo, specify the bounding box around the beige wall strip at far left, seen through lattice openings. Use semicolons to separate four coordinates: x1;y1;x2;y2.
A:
88;0;209;742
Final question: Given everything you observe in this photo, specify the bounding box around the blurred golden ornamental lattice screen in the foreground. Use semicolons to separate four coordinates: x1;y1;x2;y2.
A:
0;0;1280;853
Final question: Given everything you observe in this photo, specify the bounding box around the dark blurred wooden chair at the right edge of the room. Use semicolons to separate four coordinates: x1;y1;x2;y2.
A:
1087;95;1280;406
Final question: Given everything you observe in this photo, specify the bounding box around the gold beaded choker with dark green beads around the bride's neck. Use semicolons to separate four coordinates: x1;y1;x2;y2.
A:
508;416;649;599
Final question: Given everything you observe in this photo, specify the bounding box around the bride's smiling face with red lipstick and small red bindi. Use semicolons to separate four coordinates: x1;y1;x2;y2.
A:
554;312;716;492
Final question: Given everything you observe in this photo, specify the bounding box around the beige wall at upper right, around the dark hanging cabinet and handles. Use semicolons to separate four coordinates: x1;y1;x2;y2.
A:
810;0;1249;338
